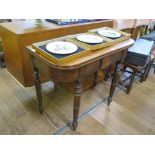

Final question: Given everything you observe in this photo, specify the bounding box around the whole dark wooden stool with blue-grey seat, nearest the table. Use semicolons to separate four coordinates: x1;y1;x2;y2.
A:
124;39;154;94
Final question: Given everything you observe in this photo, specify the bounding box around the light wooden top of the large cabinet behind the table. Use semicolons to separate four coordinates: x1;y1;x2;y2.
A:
0;20;112;35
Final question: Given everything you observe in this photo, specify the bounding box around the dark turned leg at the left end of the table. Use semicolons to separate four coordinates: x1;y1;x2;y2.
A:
34;67;43;114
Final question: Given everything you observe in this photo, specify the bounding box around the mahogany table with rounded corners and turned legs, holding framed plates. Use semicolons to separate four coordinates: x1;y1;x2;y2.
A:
27;39;134;130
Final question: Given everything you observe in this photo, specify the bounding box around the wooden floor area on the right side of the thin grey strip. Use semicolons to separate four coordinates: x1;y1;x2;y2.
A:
64;76;155;135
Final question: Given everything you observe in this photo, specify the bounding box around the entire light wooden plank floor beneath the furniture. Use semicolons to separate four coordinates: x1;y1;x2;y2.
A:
0;69;155;135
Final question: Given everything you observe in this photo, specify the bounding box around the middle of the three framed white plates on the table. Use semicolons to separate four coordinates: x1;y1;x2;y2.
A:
76;34;103;44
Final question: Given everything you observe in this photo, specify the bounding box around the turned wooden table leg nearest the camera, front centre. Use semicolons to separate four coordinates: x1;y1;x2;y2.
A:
72;80;82;130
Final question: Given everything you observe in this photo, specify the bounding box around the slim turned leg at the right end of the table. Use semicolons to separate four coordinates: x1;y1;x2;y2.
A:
108;64;119;105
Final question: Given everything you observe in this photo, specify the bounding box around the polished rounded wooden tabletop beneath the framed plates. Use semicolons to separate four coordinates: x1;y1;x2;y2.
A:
28;39;134;69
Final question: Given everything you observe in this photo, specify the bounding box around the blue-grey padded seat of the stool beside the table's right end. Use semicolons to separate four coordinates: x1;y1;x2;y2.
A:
126;38;154;67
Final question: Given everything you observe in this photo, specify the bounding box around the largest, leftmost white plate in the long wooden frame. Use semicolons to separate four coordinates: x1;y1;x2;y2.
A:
46;41;78;54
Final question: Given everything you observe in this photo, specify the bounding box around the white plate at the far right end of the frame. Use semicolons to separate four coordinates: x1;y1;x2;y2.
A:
98;29;121;38
